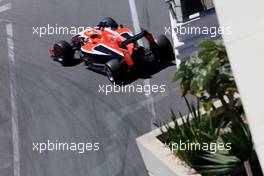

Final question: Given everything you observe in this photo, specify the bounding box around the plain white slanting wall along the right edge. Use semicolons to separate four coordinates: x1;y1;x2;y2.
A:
215;0;264;173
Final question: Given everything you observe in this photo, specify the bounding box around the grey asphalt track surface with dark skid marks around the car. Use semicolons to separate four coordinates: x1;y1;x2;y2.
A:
0;0;188;176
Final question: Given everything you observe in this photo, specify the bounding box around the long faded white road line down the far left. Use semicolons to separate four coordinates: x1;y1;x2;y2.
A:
6;23;20;176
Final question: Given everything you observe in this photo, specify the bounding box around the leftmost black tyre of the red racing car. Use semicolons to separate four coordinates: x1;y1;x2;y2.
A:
53;41;74;65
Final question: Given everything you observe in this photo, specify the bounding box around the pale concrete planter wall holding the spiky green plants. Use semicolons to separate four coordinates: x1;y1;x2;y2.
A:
136;124;201;176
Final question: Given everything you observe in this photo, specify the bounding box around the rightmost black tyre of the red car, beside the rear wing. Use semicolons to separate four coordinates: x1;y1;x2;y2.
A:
155;35;175;63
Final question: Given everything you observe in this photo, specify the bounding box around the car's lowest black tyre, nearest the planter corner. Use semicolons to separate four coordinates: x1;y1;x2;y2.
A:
105;59;122;84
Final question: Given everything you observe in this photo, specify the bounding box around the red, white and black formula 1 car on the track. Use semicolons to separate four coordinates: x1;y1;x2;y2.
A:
50;17;174;84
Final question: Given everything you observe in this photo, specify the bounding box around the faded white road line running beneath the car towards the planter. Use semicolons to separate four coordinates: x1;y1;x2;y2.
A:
128;0;156;129
